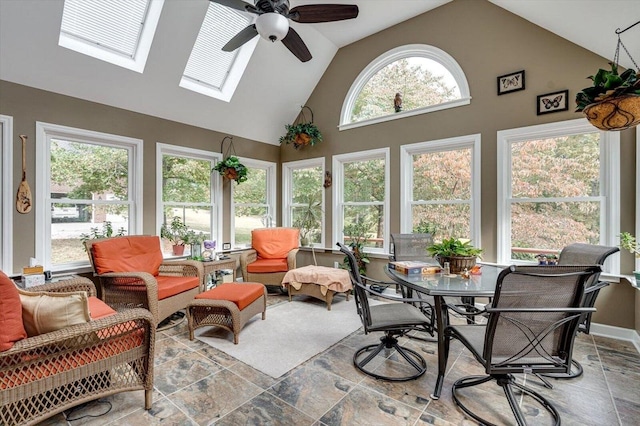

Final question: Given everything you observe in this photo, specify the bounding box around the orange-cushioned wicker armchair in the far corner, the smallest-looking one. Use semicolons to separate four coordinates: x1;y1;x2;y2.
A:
240;227;300;292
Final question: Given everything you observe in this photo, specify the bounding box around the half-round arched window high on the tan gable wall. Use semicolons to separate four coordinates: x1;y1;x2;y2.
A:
340;44;471;130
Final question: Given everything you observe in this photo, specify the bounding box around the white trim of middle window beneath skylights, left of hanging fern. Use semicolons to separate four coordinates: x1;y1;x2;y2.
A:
156;142;223;250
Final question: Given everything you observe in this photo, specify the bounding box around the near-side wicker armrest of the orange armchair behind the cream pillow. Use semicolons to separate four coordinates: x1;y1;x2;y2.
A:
98;272;158;318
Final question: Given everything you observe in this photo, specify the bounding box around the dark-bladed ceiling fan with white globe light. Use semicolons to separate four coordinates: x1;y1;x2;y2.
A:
209;0;358;62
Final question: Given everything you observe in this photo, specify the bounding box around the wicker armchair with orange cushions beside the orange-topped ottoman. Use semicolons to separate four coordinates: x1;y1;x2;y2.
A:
85;235;204;324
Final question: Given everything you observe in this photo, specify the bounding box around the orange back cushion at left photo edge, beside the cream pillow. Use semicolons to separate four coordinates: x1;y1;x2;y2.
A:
0;271;27;352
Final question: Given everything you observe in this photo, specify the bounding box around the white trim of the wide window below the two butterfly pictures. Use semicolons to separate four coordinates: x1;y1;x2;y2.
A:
497;118;620;274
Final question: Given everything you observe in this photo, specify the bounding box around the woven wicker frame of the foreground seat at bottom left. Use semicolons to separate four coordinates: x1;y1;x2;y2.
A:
0;277;155;425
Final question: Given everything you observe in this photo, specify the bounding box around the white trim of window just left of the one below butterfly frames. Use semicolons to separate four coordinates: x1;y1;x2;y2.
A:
400;133;482;247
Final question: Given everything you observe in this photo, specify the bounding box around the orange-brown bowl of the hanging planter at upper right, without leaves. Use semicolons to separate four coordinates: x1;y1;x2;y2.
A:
583;95;640;130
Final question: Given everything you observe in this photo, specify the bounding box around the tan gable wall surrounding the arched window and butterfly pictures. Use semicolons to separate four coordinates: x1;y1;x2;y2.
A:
282;0;640;330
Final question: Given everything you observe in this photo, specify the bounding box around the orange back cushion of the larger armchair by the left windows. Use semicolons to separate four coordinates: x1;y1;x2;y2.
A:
91;235;163;276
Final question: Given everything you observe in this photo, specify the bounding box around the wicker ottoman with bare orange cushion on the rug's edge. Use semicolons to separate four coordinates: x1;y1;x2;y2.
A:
187;283;267;345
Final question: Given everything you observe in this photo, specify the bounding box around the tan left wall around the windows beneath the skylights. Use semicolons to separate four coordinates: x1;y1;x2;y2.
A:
0;81;280;271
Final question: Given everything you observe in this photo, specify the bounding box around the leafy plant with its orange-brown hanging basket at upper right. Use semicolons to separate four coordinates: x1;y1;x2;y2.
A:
576;62;640;130
